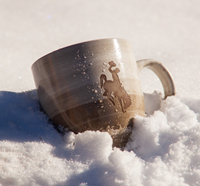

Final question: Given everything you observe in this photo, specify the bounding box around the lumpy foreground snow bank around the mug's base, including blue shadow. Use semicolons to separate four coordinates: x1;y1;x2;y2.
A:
0;90;200;186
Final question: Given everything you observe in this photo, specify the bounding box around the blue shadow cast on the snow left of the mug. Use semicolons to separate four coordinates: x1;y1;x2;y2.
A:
0;90;62;145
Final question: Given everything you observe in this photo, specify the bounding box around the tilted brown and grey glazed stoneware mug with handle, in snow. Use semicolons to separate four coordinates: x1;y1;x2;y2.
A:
32;39;175;148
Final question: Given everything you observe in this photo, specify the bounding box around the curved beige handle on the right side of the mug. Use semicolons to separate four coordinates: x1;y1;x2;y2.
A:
137;59;176;99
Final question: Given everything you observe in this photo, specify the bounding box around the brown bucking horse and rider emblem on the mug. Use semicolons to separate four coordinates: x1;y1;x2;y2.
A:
100;61;131;112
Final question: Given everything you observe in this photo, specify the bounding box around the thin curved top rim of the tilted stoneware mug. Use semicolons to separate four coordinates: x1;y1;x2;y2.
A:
31;38;127;68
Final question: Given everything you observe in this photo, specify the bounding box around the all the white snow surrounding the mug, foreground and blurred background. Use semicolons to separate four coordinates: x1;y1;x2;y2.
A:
0;0;200;186
